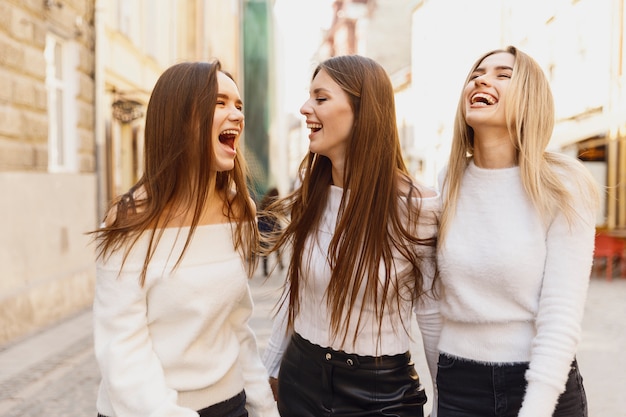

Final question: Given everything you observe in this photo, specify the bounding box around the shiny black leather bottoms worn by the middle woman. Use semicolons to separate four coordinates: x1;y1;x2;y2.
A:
278;334;426;417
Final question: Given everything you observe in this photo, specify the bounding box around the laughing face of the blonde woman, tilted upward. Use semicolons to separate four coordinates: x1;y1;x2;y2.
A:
463;52;515;132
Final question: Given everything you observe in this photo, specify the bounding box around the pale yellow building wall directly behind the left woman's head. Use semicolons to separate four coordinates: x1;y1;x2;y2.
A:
97;0;241;202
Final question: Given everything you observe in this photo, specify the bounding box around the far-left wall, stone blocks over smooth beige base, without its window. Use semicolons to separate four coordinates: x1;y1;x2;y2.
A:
0;0;96;344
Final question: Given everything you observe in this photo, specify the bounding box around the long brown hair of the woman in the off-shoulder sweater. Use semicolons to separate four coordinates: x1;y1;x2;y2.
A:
93;61;258;285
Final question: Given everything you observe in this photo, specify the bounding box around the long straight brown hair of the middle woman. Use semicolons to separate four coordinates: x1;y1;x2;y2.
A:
268;55;434;348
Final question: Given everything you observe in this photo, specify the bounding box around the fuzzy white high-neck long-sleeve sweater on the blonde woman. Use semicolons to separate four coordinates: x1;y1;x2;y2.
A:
438;161;595;417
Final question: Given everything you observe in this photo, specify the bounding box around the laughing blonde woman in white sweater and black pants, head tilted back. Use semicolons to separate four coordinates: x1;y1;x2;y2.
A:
437;47;598;417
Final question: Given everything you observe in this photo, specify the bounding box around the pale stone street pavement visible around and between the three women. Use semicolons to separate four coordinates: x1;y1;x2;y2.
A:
0;264;626;417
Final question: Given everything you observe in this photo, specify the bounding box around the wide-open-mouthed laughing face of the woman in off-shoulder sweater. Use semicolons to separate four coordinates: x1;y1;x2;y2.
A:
211;72;244;172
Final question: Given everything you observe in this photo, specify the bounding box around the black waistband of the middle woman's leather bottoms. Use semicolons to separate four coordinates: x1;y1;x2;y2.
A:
291;333;411;369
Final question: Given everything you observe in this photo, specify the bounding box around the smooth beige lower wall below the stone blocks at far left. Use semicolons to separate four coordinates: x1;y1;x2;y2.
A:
0;172;96;344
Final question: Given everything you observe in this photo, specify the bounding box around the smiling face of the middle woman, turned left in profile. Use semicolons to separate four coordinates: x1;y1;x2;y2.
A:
300;69;354;165
